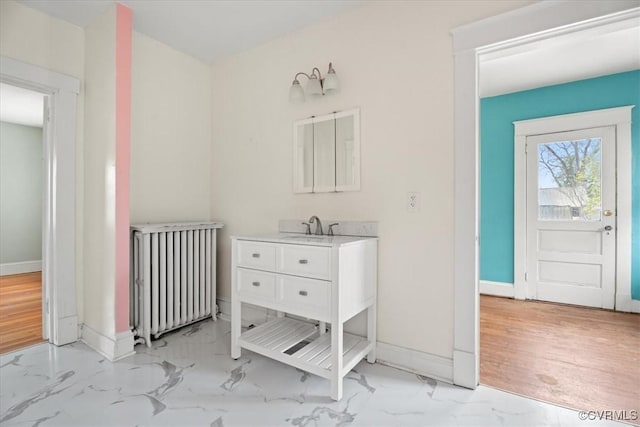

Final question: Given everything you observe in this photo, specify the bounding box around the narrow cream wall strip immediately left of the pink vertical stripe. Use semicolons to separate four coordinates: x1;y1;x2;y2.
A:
83;5;116;337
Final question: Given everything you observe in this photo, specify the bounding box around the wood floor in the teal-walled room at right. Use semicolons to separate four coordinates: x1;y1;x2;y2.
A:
480;295;640;423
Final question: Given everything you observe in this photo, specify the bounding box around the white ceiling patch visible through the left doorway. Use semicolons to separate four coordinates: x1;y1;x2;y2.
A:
0;83;44;127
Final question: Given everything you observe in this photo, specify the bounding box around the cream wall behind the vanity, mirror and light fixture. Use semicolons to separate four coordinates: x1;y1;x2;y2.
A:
211;1;528;358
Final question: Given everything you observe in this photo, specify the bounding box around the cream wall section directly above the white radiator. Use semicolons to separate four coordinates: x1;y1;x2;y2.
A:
130;32;211;223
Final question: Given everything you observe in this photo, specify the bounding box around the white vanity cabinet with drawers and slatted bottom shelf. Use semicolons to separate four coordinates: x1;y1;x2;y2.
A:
231;234;378;400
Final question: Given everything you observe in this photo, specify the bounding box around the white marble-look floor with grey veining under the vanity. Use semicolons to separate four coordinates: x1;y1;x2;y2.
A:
0;320;619;427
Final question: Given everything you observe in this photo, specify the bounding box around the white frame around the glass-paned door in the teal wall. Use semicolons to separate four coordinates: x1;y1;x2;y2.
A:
513;105;634;311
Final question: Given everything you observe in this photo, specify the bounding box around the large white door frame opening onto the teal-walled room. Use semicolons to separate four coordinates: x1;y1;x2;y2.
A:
451;0;640;388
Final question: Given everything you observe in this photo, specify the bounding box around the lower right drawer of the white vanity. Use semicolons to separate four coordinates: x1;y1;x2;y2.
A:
278;276;331;317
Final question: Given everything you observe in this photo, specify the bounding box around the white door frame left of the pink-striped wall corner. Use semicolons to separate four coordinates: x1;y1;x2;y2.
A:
0;56;80;345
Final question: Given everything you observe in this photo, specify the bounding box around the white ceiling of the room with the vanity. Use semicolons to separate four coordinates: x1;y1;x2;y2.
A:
18;0;366;64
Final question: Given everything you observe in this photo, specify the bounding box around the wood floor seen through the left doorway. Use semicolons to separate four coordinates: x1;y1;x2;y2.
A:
0;272;42;354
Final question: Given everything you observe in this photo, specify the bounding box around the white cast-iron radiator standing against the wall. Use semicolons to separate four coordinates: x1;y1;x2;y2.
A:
129;222;223;347
